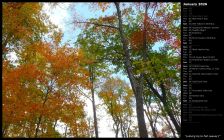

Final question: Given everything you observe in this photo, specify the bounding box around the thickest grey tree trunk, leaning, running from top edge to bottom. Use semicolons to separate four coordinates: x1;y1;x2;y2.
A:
115;2;148;138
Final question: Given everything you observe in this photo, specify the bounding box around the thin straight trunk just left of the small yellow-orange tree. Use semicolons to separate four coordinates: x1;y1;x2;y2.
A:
89;66;99;138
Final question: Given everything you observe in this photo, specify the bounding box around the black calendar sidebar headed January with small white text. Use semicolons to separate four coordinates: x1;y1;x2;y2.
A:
181;0;224;139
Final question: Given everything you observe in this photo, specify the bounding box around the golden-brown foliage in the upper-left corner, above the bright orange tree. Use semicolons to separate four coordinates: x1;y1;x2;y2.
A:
2;2;55;58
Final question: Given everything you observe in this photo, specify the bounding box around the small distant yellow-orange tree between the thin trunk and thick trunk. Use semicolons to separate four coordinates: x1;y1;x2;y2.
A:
99;78;133;138
